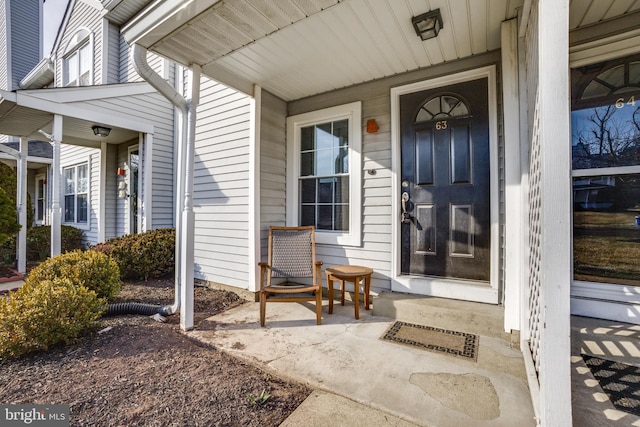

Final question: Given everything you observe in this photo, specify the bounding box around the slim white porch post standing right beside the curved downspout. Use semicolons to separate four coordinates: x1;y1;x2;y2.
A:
179;64;200;331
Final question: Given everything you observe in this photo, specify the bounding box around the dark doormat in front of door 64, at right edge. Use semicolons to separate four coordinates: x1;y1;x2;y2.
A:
582;354;640;416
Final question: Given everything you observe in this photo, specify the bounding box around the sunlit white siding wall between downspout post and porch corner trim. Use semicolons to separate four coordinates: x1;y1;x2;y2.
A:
194;77;255;289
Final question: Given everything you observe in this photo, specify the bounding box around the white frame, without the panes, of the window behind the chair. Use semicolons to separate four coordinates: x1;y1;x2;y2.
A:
287;101;362;246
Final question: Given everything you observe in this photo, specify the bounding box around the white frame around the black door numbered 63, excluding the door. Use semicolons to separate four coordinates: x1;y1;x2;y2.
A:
391;65;500;304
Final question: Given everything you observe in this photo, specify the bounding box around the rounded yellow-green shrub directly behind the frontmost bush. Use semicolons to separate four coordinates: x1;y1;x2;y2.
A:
25;250;122;300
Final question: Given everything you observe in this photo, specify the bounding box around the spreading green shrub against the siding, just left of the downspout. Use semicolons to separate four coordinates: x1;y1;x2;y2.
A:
91;228;176;280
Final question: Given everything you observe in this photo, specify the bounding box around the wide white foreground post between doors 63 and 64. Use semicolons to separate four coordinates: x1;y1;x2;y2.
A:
537;0;572;426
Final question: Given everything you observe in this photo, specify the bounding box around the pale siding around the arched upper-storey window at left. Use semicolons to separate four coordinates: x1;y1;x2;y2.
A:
55;1;103;87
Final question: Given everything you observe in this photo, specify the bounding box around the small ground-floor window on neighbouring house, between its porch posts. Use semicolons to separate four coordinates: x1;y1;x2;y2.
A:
62;163;89;224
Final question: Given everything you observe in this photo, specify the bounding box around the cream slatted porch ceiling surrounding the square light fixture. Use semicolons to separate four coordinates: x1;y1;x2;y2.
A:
123;0;640;100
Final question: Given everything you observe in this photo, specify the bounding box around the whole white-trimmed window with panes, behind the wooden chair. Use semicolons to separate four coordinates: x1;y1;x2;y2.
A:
287;102;362;246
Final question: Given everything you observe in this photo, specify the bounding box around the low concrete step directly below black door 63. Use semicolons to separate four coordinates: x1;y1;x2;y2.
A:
373;292;511;341
